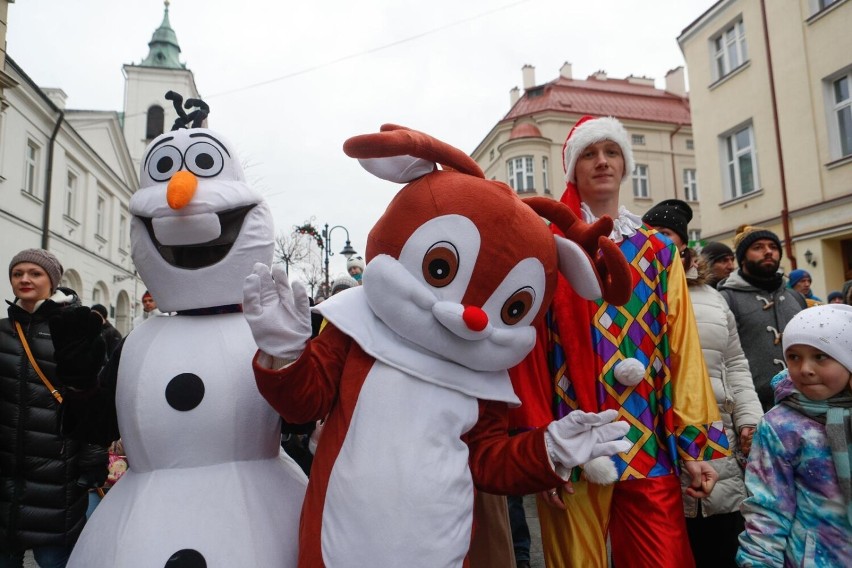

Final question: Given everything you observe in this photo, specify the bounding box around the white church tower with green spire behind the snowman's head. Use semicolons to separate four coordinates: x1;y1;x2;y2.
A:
123;0;199;174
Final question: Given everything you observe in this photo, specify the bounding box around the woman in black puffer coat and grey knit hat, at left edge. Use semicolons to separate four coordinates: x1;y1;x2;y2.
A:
0;249;107;566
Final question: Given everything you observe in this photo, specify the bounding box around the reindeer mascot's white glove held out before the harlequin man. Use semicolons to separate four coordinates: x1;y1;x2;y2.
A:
544;410;633;469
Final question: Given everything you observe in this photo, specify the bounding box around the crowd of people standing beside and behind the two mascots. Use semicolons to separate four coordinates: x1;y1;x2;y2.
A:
0;113;852;568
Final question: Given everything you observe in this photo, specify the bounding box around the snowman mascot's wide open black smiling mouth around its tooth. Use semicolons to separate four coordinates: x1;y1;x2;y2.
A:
139;203;255;270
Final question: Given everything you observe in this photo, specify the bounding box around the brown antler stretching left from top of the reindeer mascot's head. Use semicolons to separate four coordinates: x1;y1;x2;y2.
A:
343;124;485;178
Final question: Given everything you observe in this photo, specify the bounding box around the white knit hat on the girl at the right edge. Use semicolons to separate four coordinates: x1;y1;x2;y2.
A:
782;304;852;372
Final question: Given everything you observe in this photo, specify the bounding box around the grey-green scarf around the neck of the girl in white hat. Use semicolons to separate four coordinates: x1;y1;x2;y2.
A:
781;389;852;523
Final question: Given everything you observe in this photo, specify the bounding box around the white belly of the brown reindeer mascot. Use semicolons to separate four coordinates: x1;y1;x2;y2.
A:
322;361;479;568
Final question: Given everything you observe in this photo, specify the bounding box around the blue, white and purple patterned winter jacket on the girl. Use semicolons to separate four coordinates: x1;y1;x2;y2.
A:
737;372;852;568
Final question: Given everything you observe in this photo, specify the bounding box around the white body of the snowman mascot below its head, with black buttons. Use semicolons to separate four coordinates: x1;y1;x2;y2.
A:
69;316;307;568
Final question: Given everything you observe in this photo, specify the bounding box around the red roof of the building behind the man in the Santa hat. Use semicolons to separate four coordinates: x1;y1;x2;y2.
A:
503;76;692;124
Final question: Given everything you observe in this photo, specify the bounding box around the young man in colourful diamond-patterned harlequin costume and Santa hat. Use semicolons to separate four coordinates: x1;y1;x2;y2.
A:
513;116;727;568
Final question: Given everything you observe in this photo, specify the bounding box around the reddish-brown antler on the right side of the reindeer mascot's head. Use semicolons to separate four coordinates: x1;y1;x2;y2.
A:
522;197;633;306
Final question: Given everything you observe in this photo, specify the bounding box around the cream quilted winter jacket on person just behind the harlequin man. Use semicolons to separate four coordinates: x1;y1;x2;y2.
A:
681;282;763;518
